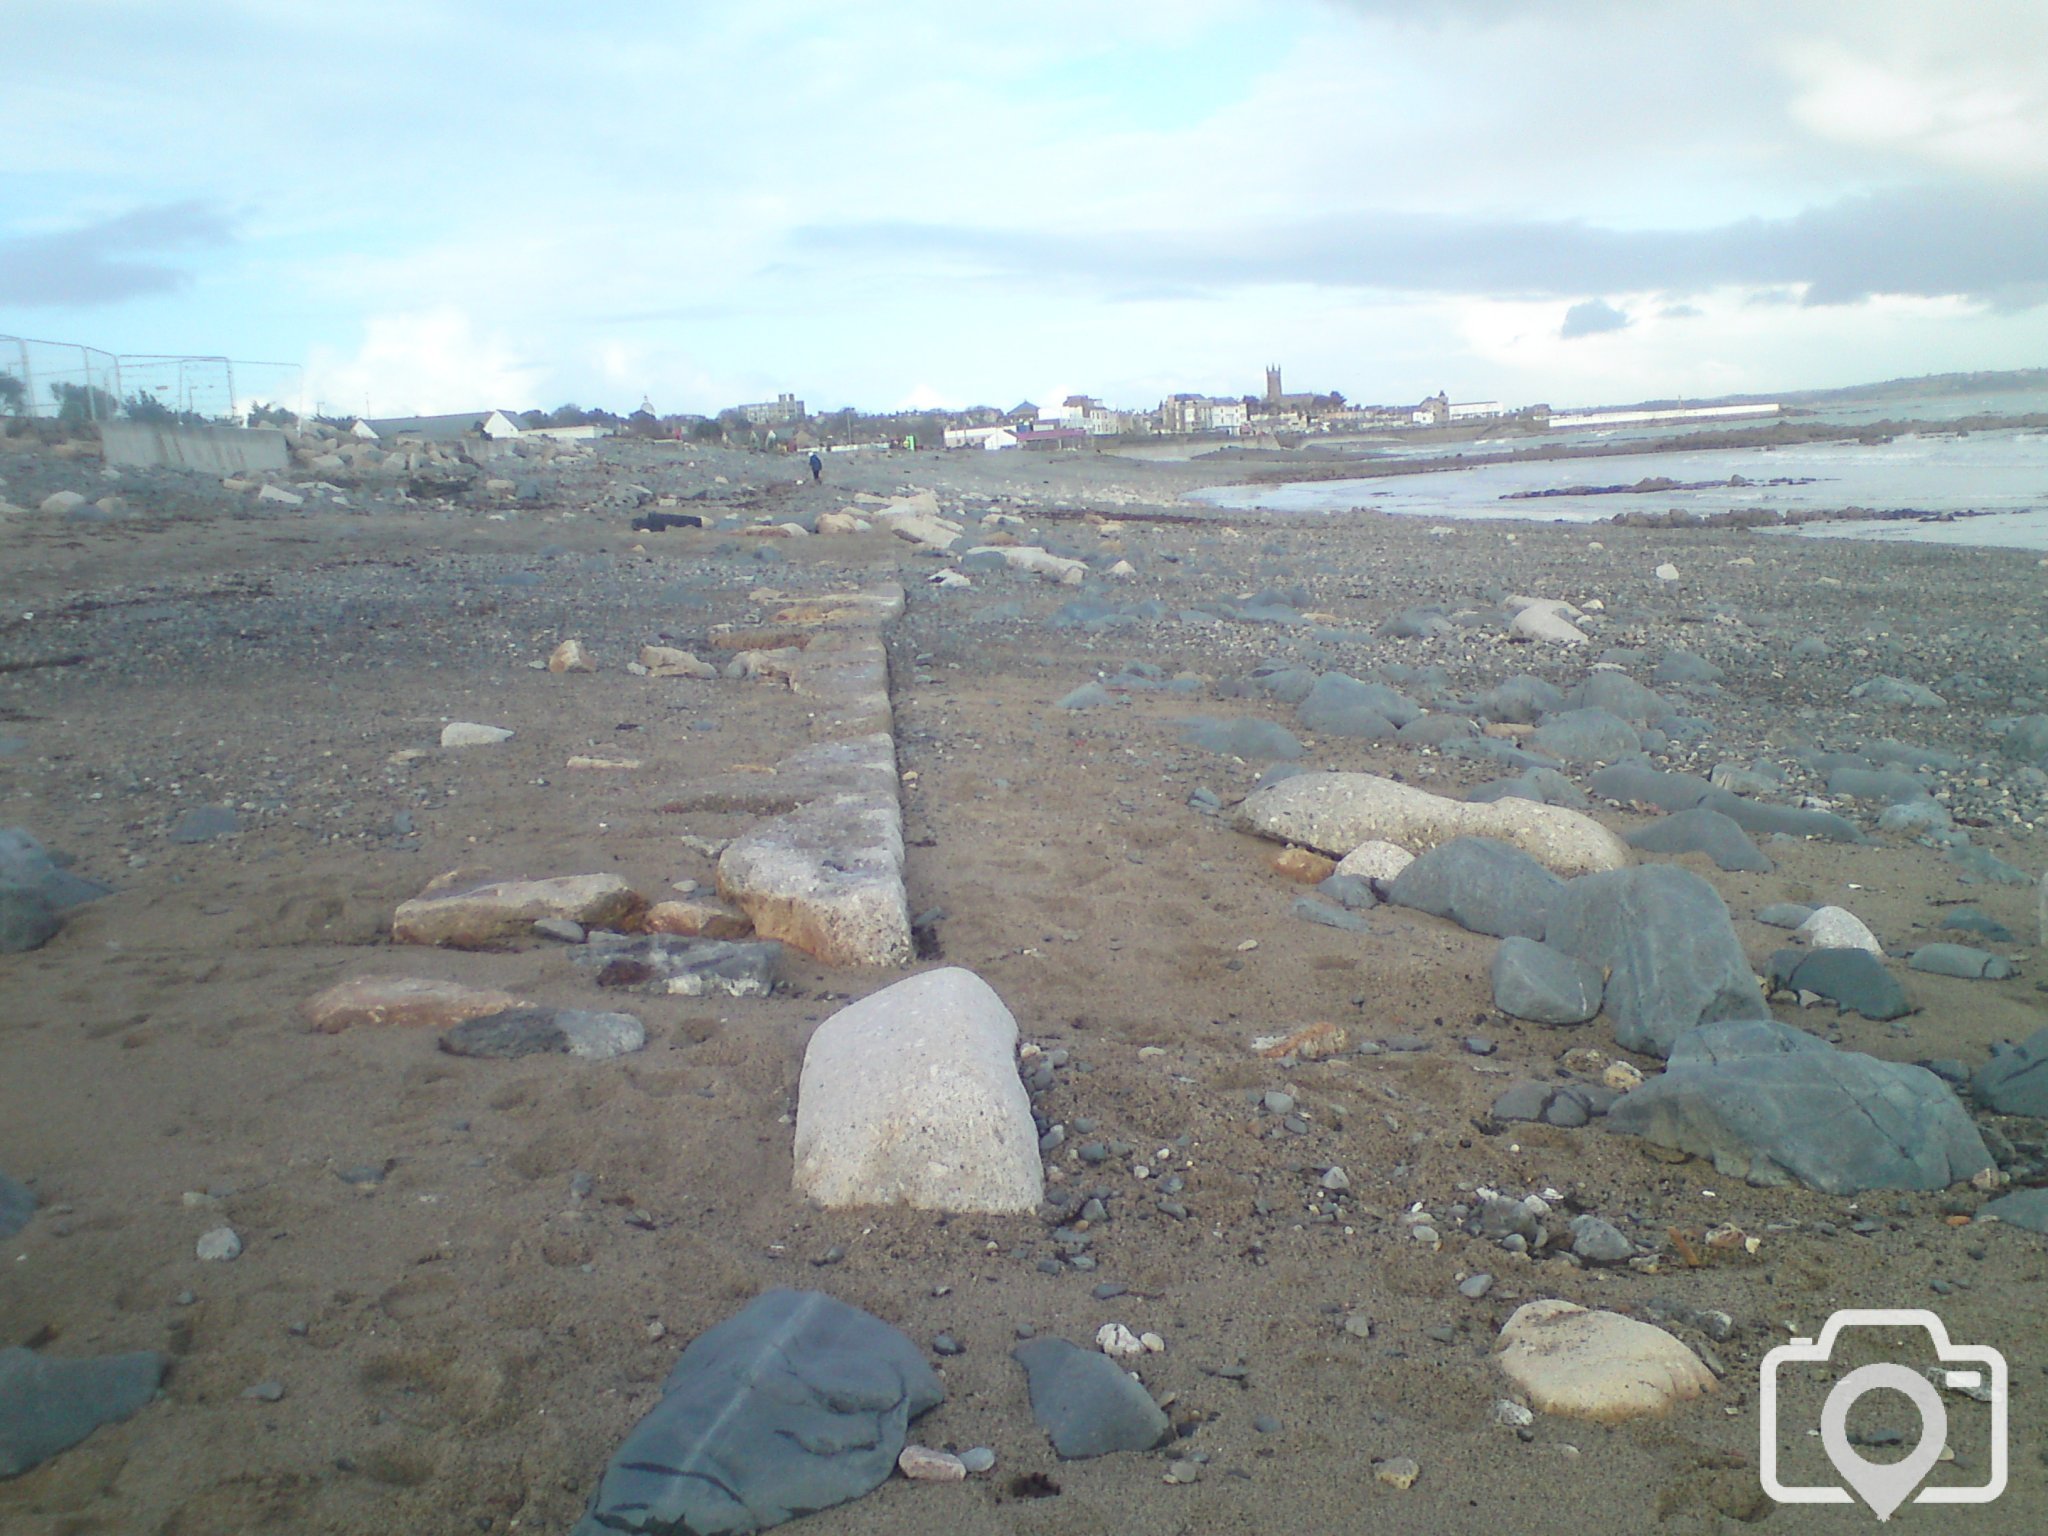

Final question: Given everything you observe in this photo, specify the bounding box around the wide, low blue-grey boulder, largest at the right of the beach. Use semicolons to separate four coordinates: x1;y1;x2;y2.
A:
1608;1020;1993;1194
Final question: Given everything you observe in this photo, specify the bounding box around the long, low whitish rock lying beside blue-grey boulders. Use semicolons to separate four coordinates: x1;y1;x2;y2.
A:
1231;774;1632;879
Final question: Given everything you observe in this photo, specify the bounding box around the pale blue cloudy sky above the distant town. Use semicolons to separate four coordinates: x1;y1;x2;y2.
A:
0;0;2048;414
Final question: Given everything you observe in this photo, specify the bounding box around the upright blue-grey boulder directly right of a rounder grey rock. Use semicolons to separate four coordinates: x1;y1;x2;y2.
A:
1544;864;1765;1057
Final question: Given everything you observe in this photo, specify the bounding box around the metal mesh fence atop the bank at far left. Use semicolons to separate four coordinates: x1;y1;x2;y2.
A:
0;336;305;422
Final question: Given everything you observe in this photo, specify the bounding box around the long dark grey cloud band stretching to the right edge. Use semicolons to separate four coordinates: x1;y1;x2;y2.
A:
791;186;2048;305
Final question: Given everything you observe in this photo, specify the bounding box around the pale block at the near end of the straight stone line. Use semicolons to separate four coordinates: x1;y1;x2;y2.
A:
719;782;913;967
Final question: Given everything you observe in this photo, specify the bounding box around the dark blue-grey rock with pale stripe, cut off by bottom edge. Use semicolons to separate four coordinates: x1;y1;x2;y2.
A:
573;1290;946;1536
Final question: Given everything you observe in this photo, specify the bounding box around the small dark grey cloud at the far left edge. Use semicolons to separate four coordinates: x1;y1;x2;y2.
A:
0;203;231;309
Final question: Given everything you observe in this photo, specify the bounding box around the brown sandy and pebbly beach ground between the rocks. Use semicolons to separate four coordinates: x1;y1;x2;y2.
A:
0;442;2048;1536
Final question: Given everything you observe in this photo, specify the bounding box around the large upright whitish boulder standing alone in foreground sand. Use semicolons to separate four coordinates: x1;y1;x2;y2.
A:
793;967;1044;1212
